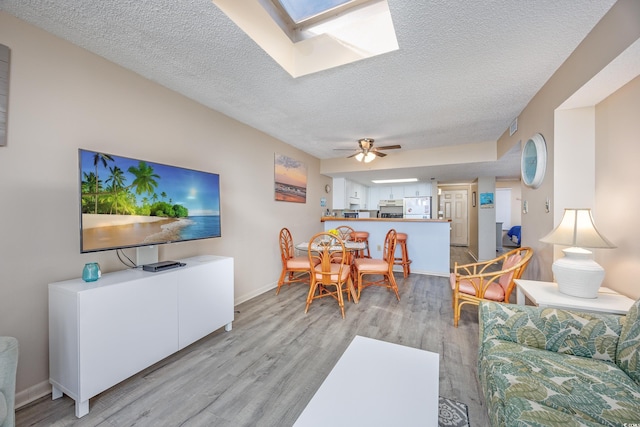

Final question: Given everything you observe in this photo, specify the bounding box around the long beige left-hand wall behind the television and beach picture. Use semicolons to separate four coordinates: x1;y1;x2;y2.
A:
0;13;330;405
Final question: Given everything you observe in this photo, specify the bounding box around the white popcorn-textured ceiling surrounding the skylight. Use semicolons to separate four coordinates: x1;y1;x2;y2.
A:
0;0;614;181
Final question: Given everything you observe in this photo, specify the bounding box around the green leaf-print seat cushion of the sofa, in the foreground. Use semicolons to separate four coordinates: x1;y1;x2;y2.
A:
479;339;640;427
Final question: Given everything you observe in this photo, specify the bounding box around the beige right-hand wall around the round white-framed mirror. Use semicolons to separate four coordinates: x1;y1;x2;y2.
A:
498;0;640;284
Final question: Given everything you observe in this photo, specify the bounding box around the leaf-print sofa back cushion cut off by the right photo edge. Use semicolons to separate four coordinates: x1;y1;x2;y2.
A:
616;300;640;385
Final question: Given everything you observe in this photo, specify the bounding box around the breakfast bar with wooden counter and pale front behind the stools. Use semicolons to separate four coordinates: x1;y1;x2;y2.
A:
321;216;451;277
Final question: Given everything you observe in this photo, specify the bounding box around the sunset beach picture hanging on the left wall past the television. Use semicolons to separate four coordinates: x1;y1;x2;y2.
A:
274;153;307;203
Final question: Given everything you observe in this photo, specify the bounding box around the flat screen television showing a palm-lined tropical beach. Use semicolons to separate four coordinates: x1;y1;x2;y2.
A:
78;149;221;253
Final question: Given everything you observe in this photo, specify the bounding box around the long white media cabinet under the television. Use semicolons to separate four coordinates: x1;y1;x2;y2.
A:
49;255;234;418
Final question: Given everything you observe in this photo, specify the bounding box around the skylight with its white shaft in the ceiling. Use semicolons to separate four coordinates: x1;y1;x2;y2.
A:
212;0;398;78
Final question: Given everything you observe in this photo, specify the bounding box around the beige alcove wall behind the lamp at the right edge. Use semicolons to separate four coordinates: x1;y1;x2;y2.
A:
594;76;640;299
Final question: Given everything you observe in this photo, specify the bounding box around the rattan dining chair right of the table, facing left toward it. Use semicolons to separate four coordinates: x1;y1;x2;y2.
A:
354;228;400;301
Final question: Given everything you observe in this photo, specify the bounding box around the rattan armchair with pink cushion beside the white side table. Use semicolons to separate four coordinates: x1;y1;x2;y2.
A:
449;247;533;327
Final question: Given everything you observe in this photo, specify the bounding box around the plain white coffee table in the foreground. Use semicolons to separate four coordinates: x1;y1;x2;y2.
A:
294;336;440;427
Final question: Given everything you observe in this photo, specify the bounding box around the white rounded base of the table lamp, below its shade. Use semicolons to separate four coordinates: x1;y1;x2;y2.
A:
551;248;604;298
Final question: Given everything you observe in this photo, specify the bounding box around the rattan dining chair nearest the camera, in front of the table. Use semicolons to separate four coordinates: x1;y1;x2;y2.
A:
304;232;357;319
